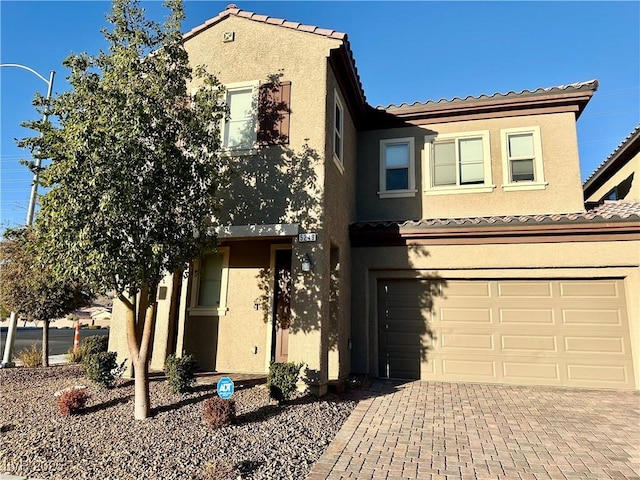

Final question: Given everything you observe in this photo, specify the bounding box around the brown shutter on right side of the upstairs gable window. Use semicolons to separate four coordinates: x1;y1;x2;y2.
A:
258;82;291;145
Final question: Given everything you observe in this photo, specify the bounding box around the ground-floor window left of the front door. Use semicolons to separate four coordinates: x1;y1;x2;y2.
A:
190;247;229;315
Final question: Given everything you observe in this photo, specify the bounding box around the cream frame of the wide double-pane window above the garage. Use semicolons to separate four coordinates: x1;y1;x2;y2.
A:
424;130;496;195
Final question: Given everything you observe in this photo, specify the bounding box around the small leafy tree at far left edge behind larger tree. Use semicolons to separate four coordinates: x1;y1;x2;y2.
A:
0;228;90;367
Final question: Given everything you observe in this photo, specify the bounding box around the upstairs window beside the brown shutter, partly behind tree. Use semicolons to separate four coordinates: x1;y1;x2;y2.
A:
222;82;258;150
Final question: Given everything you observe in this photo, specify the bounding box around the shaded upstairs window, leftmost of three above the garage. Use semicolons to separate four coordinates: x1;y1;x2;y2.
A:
378;138;416;198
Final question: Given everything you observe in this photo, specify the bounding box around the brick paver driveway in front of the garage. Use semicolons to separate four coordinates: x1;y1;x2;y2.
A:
307;381;640;480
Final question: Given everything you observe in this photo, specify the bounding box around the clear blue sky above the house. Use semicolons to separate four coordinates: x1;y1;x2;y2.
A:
0;0;640;230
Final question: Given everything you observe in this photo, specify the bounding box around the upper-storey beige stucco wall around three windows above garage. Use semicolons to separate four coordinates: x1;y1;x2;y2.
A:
357;113;584;220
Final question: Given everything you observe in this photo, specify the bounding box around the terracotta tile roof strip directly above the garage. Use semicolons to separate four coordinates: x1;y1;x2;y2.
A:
352;201;640;229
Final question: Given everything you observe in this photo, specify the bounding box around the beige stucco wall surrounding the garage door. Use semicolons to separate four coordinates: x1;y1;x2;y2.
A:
351;241;640;386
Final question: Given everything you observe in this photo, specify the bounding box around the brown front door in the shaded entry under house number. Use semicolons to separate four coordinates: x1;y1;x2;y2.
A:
271;249;291;363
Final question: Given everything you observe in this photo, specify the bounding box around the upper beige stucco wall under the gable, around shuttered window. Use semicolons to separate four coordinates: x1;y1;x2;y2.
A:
185;16;340;228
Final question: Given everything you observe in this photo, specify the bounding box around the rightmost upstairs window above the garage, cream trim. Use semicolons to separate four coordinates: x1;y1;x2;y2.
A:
501;127;547;191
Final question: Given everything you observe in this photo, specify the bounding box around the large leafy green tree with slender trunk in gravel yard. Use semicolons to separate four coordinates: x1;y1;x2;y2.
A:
20;0;228;419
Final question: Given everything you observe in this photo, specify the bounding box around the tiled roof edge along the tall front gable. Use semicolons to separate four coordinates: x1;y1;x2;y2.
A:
182;4;366;107
